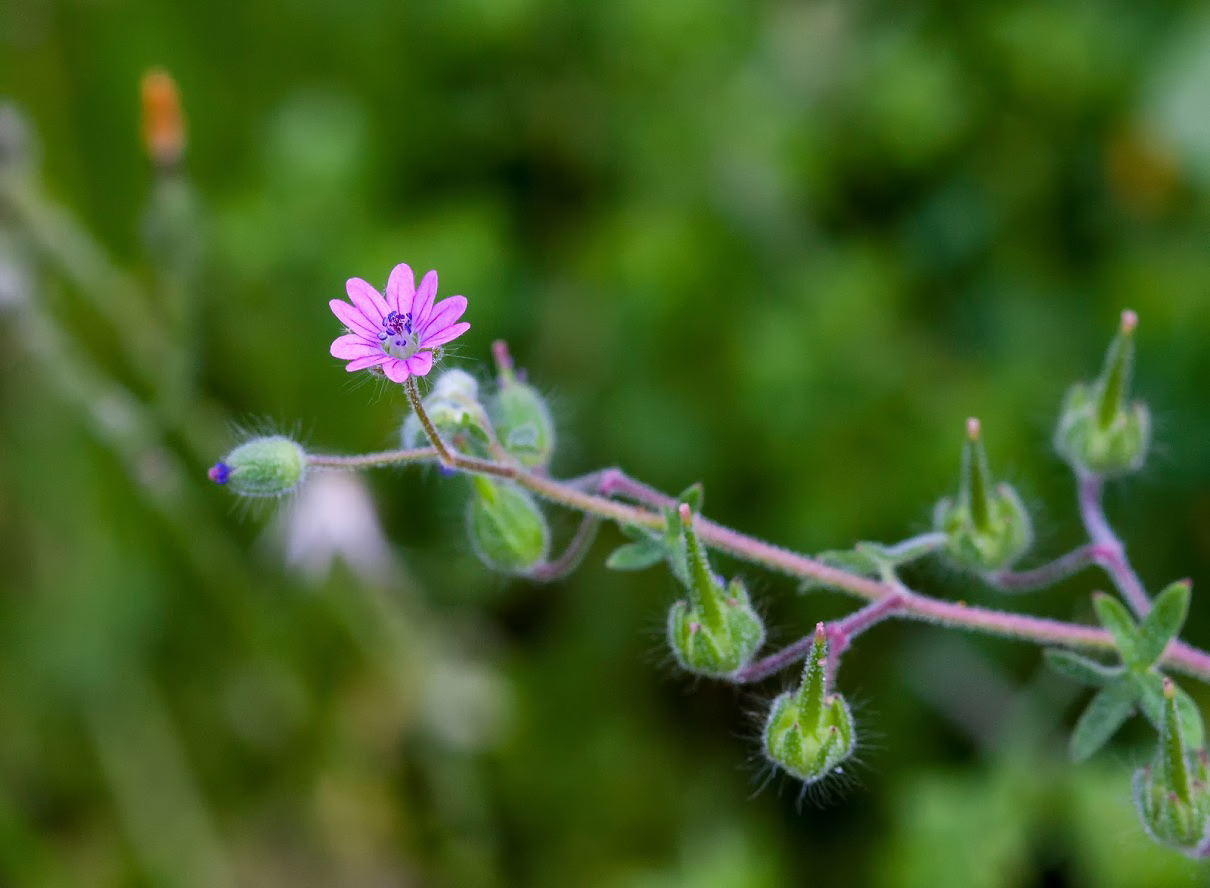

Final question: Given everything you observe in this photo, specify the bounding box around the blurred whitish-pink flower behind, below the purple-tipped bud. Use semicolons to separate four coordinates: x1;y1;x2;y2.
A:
277;472;397;584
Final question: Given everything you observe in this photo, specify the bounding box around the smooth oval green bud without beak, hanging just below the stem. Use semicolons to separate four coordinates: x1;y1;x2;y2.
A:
466;475;551;573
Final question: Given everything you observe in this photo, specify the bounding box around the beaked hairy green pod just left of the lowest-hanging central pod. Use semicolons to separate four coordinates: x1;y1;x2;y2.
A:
668;503;765;677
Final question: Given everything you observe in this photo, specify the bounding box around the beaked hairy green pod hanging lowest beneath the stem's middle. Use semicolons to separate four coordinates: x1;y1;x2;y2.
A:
762;623;857;783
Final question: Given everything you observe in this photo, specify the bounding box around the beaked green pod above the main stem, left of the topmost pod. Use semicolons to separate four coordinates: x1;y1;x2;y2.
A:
934;419;1033;573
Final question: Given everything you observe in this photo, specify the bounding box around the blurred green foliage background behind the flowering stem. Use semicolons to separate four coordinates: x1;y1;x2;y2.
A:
0;0;1210;888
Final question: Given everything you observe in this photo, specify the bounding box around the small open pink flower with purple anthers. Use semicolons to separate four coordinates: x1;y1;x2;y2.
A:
328;264;471;382
